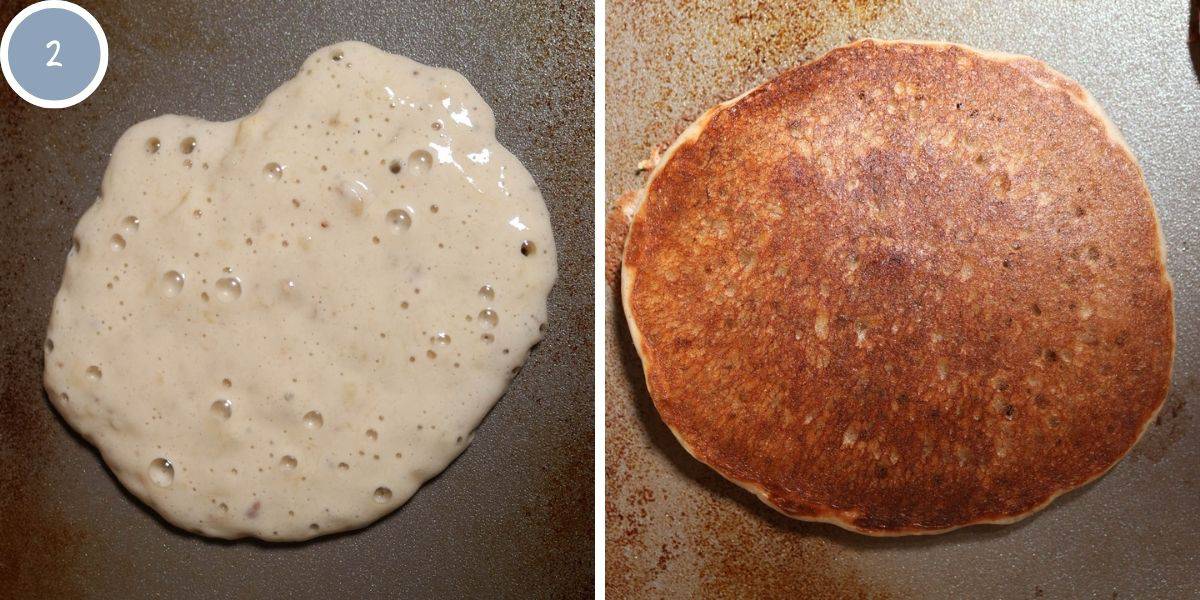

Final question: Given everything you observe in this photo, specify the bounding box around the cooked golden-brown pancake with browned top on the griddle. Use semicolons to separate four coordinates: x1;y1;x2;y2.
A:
622;41;1174;535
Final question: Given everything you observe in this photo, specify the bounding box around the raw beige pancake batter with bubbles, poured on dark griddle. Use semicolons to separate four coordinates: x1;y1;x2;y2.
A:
44;42;557;541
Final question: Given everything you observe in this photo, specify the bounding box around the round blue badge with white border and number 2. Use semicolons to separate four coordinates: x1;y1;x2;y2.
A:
0;0;108;108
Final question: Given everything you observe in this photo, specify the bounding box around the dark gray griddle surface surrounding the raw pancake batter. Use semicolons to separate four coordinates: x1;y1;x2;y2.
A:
0;0;594;599
